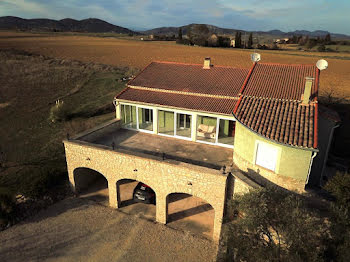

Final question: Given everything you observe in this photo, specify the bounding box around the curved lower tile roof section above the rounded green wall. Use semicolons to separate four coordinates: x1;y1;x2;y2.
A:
235;96;315;148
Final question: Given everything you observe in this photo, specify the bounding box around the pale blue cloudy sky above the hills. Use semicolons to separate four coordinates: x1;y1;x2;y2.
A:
0;0;350;35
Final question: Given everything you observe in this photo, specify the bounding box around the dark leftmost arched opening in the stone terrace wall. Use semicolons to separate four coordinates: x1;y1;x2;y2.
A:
73;167;109;206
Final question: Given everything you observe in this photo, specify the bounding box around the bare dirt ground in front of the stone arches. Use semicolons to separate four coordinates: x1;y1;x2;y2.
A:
0;197;216;262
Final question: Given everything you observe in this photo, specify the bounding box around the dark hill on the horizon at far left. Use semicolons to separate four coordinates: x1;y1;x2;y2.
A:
0;16;135;34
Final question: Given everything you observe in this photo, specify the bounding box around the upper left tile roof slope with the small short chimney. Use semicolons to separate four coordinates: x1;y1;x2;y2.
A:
128;62;249;97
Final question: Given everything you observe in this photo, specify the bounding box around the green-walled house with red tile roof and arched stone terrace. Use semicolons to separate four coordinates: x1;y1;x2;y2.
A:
64;58;337;240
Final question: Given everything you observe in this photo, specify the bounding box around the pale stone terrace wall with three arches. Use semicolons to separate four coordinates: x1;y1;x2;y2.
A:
64;140;252;240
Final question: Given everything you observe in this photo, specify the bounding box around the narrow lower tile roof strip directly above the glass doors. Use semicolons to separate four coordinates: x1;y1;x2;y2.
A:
117;87;237;115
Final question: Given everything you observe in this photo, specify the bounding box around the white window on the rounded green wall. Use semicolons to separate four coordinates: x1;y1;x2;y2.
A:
255;142;278;171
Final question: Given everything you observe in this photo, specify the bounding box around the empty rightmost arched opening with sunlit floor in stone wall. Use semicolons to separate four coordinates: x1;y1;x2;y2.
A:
166;193;215;238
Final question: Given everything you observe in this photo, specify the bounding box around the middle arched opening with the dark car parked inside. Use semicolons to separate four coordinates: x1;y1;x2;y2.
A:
117;179;157;221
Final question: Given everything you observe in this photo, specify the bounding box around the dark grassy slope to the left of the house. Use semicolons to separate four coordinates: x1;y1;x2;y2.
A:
0;50;127;209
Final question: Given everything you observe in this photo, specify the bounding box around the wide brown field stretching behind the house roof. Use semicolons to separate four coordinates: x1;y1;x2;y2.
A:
0;32;350;98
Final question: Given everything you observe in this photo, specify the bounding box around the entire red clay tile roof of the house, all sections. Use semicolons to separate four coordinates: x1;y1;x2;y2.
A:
116;59;319;148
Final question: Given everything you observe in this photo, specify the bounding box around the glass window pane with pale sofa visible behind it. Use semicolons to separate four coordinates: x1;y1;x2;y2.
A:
197;115;217;143
